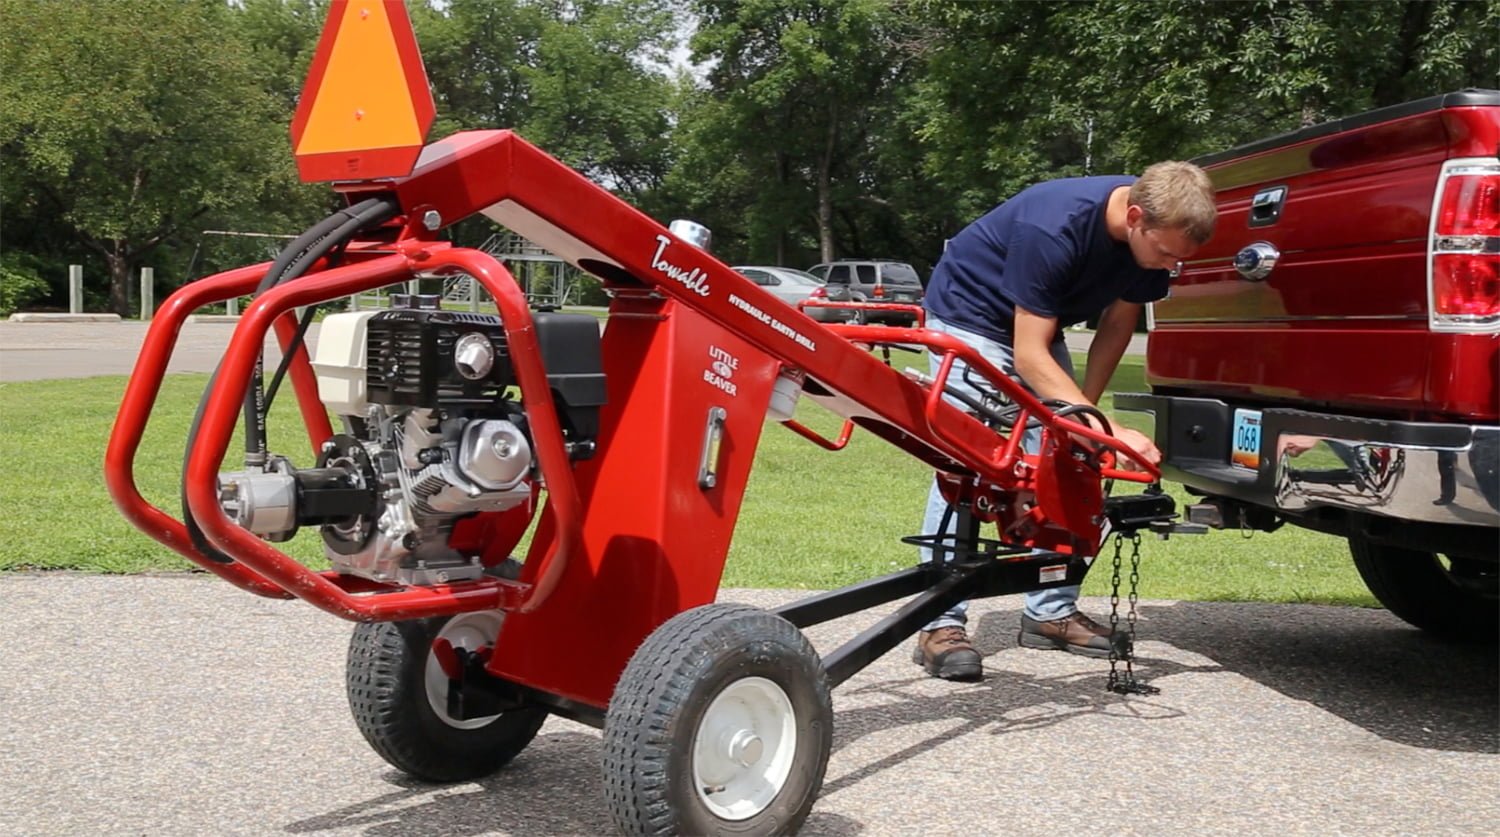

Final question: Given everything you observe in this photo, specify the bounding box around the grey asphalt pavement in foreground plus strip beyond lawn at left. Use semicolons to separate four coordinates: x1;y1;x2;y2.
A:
0;318;1500;837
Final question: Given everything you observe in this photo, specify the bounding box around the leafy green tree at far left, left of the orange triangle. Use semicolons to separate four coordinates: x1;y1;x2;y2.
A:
0;0;304;314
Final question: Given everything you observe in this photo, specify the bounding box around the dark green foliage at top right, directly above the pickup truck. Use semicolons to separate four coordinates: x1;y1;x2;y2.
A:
1053;0;1500;167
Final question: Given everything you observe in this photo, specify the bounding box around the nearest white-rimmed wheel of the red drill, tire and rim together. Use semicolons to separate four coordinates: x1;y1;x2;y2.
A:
603;605;833;834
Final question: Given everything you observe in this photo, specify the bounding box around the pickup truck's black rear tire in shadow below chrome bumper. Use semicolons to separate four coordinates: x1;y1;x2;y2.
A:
1349;536;1500;644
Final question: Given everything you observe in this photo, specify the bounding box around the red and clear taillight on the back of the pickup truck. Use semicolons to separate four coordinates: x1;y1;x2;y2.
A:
1427;159;1500;332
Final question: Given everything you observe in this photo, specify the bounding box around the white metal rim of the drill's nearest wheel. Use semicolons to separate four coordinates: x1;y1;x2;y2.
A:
693;677;797;821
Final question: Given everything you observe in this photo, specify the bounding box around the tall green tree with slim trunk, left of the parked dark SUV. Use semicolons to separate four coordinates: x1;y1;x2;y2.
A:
683;0;902;263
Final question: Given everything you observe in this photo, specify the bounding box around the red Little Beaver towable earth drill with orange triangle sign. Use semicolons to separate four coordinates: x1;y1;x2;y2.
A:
105;0;1173;833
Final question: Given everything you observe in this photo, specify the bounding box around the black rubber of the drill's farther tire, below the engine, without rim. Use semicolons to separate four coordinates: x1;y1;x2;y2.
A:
345;617;548;782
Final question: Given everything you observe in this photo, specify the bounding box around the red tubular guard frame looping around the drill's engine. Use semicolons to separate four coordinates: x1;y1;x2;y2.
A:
105;242;582;621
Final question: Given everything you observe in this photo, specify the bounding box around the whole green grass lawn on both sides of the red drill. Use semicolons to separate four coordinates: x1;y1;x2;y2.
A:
0;356;1374;605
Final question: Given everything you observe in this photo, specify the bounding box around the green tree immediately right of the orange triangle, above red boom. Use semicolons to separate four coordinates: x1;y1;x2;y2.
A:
411;0;674;252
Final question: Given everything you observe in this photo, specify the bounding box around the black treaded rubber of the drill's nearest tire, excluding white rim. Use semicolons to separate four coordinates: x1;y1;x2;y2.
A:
603;605;833;834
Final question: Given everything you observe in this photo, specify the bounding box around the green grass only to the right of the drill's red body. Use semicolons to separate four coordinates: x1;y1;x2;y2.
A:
725;357;1376;606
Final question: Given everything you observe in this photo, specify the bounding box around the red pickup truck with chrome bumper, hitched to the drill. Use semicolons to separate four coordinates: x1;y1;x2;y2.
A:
1116;90;1500;642
